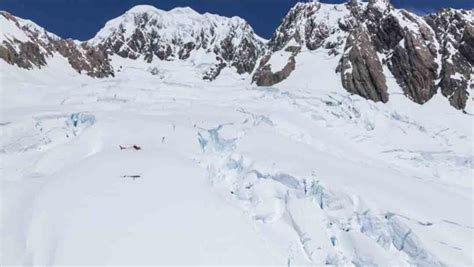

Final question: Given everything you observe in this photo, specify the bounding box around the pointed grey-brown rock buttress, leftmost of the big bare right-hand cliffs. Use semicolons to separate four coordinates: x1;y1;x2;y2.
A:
338;31;388;103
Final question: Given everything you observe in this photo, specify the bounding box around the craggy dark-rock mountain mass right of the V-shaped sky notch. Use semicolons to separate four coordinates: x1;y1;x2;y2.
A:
254;0;474;110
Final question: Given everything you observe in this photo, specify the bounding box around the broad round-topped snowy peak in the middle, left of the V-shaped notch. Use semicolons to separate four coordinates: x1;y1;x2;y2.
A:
88;5;264;80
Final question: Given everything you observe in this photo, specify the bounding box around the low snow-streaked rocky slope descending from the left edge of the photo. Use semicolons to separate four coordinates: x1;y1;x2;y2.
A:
0;11;113;78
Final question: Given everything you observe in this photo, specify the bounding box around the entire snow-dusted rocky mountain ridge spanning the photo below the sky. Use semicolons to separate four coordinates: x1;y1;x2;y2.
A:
0;0;474;110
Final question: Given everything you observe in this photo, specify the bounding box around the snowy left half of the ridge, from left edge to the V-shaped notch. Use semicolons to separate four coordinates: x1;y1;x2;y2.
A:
0;5;264;80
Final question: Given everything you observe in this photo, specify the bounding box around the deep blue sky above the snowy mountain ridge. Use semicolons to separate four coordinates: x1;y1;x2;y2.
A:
0;0;474;40
